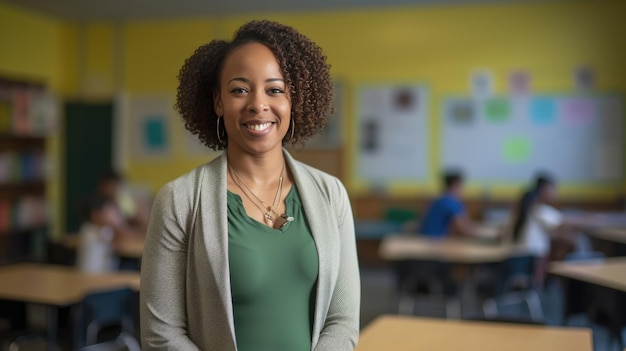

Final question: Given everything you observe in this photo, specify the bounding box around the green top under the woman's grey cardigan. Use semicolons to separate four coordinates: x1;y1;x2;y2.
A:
228;186;319;351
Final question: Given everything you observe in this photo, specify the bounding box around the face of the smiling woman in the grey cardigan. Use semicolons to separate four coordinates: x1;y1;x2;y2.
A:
214;43;291;155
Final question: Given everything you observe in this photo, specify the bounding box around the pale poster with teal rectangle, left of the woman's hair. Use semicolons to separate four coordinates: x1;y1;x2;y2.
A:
128;96;173;158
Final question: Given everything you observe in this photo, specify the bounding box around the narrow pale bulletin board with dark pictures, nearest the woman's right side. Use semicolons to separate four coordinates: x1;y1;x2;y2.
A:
353;83;428;184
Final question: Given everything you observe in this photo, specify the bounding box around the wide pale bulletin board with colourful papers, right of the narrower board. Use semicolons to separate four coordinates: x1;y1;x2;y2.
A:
440;94;625;184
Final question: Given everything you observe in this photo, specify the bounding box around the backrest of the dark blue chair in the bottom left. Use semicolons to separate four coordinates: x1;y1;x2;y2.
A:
76;288;135;347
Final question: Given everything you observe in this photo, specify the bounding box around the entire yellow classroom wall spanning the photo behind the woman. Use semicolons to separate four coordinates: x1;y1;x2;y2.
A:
0;1;626;236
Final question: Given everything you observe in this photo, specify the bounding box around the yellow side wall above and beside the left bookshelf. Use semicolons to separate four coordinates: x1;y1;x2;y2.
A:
0;3;78;236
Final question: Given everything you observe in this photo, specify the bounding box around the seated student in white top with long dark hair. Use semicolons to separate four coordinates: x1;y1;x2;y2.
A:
512;174;573;285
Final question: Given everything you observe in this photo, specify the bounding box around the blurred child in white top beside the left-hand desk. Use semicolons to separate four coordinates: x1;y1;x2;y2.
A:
76;194;120;272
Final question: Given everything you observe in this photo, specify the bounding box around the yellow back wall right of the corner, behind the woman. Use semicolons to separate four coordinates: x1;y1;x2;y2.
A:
116;1;626;198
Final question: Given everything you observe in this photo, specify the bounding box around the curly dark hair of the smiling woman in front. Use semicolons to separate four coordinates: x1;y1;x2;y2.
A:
175;20;333;150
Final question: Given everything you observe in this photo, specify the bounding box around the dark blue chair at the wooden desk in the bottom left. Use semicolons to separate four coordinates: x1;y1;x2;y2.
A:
75;288;139;351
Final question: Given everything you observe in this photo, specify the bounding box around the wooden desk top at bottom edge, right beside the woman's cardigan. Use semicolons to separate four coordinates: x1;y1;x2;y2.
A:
356;316;592;351
